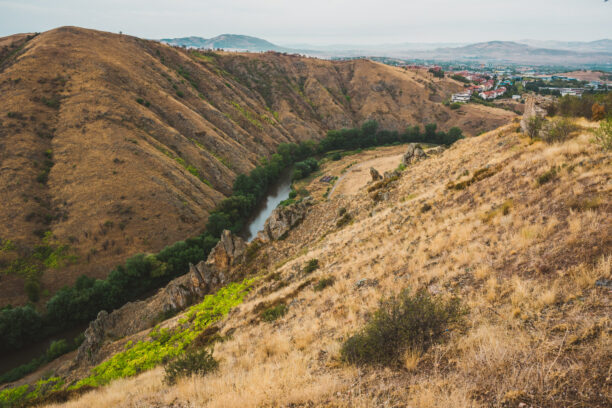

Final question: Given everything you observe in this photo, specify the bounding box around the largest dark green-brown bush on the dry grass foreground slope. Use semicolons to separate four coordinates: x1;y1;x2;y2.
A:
341;290;465;365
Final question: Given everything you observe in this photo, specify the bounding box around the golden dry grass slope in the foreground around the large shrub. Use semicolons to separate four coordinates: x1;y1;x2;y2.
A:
40;118;612;408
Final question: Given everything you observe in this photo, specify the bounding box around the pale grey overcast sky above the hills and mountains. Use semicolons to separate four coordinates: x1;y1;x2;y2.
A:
0;0;612;45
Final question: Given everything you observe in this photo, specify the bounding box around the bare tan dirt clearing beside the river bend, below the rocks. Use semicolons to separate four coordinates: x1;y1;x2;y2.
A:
329;151;403;198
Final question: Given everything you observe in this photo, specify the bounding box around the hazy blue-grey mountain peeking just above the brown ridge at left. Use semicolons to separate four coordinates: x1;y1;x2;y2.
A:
160;34;293;52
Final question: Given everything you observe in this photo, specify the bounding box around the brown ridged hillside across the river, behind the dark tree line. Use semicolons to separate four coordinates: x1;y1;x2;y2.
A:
0;27;513;305
